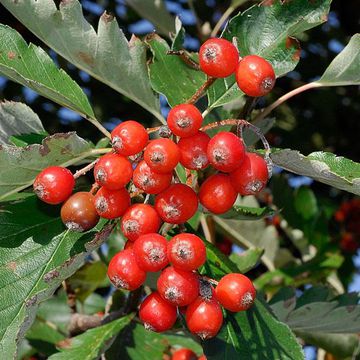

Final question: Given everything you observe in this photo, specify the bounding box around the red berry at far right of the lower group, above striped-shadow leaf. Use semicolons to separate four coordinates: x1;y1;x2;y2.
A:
215;273;256;312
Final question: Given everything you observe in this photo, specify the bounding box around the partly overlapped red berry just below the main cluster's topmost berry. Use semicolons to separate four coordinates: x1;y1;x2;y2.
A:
178;131;210;170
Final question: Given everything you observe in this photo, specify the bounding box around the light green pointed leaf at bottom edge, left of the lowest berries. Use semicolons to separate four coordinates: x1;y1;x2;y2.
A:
49;314;134;360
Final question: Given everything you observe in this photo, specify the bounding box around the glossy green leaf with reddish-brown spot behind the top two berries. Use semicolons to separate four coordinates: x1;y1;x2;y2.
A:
208;0;331;109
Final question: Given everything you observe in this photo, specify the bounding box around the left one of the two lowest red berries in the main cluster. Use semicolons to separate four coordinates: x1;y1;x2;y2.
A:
139;291;177;332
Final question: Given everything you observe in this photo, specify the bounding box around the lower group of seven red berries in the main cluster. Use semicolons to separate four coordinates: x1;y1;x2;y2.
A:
108;233;256;339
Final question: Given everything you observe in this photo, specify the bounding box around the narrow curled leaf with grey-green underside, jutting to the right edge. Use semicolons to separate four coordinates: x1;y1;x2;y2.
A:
271;149;360;195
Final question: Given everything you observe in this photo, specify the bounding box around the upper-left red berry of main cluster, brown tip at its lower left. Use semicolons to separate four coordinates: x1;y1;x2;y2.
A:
111;120;149;156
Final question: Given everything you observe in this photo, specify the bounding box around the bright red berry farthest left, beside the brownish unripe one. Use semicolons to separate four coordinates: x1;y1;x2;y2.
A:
33;166;75;205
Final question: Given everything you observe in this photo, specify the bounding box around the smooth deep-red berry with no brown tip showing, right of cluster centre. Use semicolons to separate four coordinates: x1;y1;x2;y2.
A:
198;174;237;214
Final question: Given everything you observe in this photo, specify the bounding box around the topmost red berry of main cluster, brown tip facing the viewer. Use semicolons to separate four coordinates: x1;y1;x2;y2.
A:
167;104;203;137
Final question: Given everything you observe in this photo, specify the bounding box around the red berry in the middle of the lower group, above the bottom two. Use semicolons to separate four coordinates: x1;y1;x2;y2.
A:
157;266;199;306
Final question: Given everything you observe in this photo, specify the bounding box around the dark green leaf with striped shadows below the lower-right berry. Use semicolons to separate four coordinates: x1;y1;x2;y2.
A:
204;299;304;360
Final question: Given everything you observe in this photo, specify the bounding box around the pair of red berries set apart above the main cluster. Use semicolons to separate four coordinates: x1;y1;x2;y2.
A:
199;38;275;97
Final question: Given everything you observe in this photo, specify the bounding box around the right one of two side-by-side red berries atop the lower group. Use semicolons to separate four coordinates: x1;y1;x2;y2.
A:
168;233;206;271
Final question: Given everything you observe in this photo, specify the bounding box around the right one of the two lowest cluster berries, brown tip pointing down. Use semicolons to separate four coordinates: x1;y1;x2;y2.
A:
186;296;223;340
